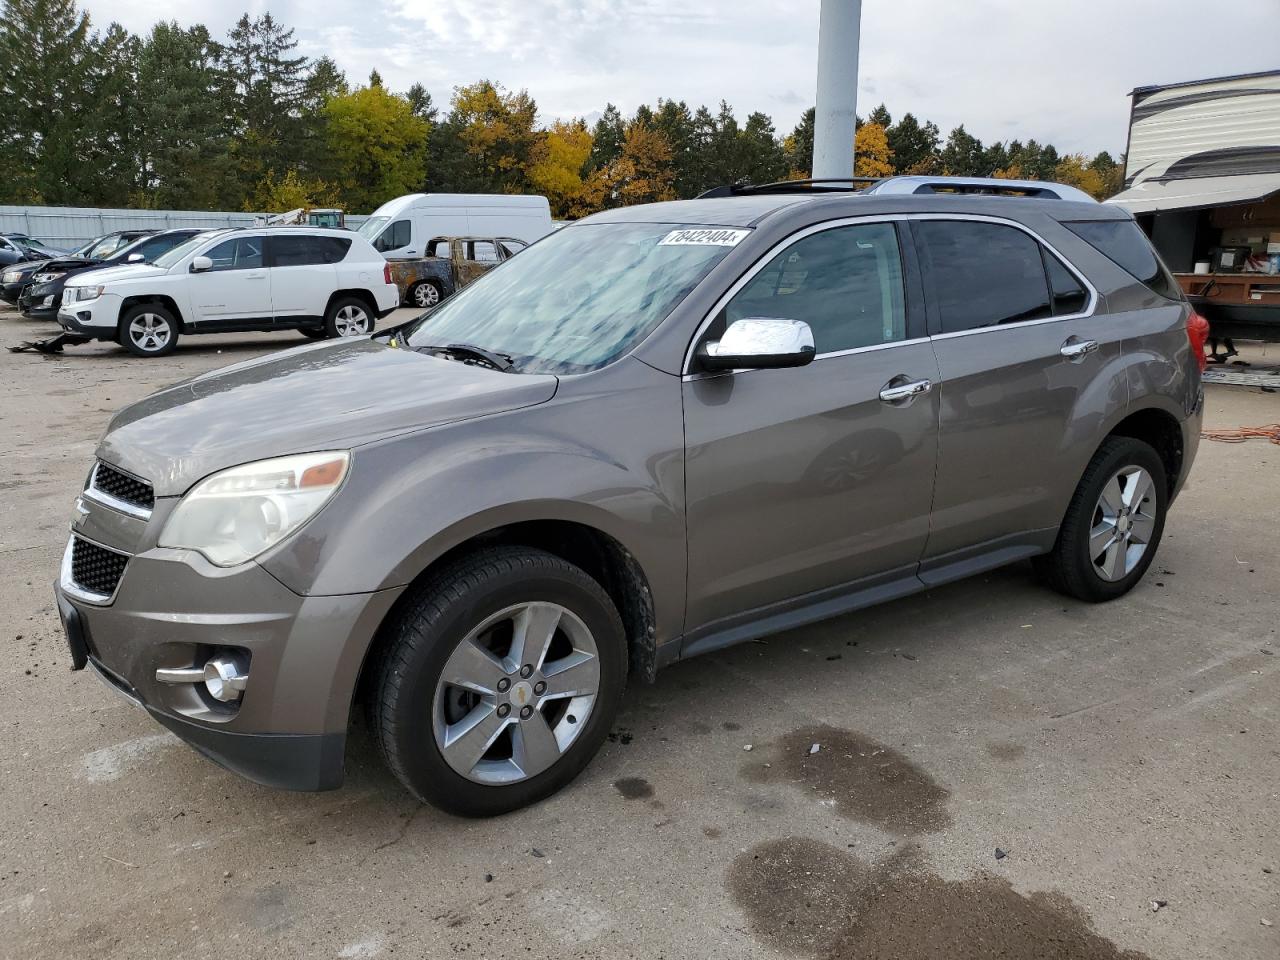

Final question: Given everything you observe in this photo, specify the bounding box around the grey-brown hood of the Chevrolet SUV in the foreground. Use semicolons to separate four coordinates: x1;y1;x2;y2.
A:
97;339;558;497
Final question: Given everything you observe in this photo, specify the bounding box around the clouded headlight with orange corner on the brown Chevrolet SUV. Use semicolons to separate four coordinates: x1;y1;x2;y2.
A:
160;451;351;567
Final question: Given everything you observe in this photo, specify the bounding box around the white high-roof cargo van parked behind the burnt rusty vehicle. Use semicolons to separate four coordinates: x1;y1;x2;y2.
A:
360;193;552;260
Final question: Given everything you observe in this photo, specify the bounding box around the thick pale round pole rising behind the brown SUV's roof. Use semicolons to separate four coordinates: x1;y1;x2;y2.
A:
813;0;863;179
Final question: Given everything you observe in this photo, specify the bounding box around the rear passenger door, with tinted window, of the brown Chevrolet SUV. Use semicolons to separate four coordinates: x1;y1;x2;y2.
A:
911;217;1125;570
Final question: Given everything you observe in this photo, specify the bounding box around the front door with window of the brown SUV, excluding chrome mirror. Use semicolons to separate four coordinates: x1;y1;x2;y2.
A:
682;223;938;632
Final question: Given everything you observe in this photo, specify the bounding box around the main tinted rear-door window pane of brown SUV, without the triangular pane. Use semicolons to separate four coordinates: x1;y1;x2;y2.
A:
914;220;1052;333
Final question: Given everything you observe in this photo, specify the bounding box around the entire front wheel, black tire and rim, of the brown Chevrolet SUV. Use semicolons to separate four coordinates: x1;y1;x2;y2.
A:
370;547;627;817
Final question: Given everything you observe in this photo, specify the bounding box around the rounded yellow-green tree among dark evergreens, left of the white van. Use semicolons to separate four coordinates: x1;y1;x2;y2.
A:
325;83;429;210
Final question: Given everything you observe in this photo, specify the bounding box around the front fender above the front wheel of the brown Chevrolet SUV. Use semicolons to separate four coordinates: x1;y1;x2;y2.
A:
261;361;686;640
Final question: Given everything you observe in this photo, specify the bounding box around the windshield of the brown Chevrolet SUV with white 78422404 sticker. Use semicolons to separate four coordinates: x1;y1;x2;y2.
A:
402;223;749;374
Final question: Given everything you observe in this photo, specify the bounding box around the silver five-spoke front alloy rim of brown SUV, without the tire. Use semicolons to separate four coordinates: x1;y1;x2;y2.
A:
433;603;600;785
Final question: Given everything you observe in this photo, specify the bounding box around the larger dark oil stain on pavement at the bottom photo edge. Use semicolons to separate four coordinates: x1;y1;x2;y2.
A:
728;837;1148;960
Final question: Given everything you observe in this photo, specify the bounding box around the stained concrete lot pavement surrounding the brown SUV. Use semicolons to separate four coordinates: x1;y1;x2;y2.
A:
0;314;1280;960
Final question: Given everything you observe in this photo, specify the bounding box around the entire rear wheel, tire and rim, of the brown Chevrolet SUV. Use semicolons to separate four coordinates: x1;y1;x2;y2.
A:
1034;436;1169;603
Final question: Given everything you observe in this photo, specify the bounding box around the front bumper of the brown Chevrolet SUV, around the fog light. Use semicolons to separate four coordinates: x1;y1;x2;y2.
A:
54;527;399;790
